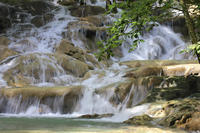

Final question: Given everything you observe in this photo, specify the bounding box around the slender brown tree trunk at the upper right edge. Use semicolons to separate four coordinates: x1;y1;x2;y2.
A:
180;0;200;64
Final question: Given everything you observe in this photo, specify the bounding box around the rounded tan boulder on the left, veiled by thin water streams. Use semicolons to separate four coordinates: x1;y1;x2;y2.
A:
4;54;56;87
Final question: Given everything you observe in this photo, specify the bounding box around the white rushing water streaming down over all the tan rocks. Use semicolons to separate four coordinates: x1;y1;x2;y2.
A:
0;0;191;122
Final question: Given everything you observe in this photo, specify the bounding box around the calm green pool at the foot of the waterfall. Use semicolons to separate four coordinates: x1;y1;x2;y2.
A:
0;117;187;133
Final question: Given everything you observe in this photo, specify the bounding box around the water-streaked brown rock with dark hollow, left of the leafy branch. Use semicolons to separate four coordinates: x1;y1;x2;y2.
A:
63;21;106;51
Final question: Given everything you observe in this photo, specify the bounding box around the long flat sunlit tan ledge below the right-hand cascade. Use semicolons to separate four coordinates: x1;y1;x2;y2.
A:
121;61;200;78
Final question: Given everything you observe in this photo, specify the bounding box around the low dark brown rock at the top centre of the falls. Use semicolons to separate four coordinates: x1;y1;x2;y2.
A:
69;5;105;17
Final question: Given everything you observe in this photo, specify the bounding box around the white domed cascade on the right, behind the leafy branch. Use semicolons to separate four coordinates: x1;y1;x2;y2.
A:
121;25;188;61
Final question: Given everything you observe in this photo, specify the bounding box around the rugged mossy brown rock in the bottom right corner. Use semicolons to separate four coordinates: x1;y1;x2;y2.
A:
158;98;200;130
